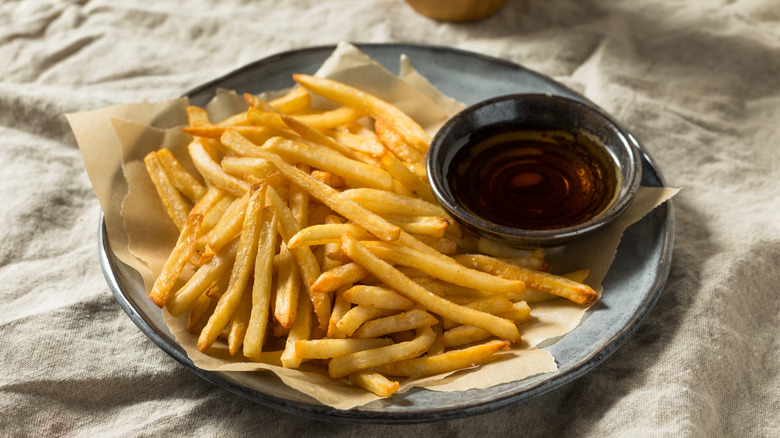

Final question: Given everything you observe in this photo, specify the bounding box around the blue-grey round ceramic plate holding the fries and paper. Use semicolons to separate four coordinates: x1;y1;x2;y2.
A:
99;44;674;423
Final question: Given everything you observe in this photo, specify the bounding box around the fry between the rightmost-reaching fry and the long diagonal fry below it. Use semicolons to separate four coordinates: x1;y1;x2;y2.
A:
360;241;525;293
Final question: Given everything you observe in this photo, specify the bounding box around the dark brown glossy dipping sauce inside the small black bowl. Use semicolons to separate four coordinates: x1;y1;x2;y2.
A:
446;131;619;230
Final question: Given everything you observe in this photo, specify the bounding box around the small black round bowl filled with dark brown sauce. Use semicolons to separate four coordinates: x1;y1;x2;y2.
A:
427;94;642;247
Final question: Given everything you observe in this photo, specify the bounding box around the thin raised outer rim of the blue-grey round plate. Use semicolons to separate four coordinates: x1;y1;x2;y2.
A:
98;43;675;424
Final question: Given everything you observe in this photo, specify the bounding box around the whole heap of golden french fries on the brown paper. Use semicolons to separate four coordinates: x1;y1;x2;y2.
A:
144;74;597;397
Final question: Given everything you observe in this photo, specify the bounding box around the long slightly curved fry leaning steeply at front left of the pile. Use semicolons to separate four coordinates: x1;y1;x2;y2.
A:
197;185;266;351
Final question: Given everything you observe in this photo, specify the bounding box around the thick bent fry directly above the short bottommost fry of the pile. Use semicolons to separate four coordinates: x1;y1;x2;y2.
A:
328;327;436;379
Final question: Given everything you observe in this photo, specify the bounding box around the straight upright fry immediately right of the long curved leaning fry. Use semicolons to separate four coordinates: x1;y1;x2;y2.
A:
244;205;277;358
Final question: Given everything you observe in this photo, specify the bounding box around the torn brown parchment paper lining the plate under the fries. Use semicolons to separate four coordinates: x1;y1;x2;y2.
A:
68;43;677;409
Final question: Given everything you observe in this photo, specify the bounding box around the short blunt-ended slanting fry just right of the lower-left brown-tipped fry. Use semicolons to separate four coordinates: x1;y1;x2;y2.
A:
165;241;238;316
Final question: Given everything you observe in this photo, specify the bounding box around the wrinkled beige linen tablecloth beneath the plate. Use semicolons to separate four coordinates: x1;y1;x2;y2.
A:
0;0;780;437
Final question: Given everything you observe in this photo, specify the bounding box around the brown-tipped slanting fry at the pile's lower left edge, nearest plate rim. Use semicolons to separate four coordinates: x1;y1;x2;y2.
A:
149;214;203;308
